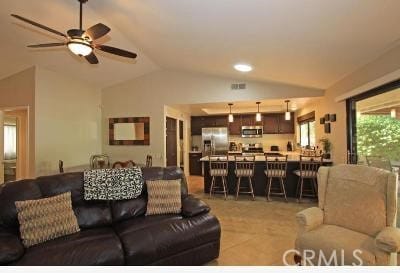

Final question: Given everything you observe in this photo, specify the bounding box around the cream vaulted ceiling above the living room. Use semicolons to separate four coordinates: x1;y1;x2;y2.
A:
0;0;400;88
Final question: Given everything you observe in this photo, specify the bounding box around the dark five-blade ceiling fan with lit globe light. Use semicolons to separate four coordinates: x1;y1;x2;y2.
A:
11;0;137;64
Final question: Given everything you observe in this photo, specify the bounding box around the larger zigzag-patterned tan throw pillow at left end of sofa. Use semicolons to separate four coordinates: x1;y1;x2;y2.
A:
15;192;80;247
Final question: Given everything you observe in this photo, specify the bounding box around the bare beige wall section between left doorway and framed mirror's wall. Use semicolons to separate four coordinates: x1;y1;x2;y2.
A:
35;68;101;176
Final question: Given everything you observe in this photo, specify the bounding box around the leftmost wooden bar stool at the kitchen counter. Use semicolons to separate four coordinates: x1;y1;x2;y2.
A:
209;156;228;200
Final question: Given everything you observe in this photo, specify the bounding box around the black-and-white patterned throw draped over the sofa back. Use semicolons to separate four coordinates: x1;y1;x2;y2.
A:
83;167;143;200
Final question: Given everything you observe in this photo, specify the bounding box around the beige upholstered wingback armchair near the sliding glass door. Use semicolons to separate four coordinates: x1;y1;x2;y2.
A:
295;165;400;265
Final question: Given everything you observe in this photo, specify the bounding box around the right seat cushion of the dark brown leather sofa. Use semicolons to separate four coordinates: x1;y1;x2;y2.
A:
114;214;221;265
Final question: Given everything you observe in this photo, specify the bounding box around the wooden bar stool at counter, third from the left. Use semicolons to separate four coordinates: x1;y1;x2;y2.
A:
265;155;288;202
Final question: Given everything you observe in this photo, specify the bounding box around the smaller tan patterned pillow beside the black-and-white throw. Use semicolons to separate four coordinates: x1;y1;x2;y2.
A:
146;179;182;215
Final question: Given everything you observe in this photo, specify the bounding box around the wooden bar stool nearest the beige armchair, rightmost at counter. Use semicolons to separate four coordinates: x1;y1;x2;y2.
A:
293;155;322;202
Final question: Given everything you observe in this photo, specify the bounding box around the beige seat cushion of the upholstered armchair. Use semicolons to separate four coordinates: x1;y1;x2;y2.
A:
296;225;387;265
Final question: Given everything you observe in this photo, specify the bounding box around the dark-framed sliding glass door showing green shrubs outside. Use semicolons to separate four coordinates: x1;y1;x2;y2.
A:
347;81;400;170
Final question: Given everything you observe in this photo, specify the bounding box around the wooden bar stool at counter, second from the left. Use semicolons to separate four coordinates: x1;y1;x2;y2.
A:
235;156;255;201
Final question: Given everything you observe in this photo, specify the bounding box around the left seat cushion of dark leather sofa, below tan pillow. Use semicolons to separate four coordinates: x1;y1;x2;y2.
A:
13;228;124;265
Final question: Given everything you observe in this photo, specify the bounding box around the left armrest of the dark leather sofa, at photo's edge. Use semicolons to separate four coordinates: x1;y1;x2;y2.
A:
0;227;24;265
